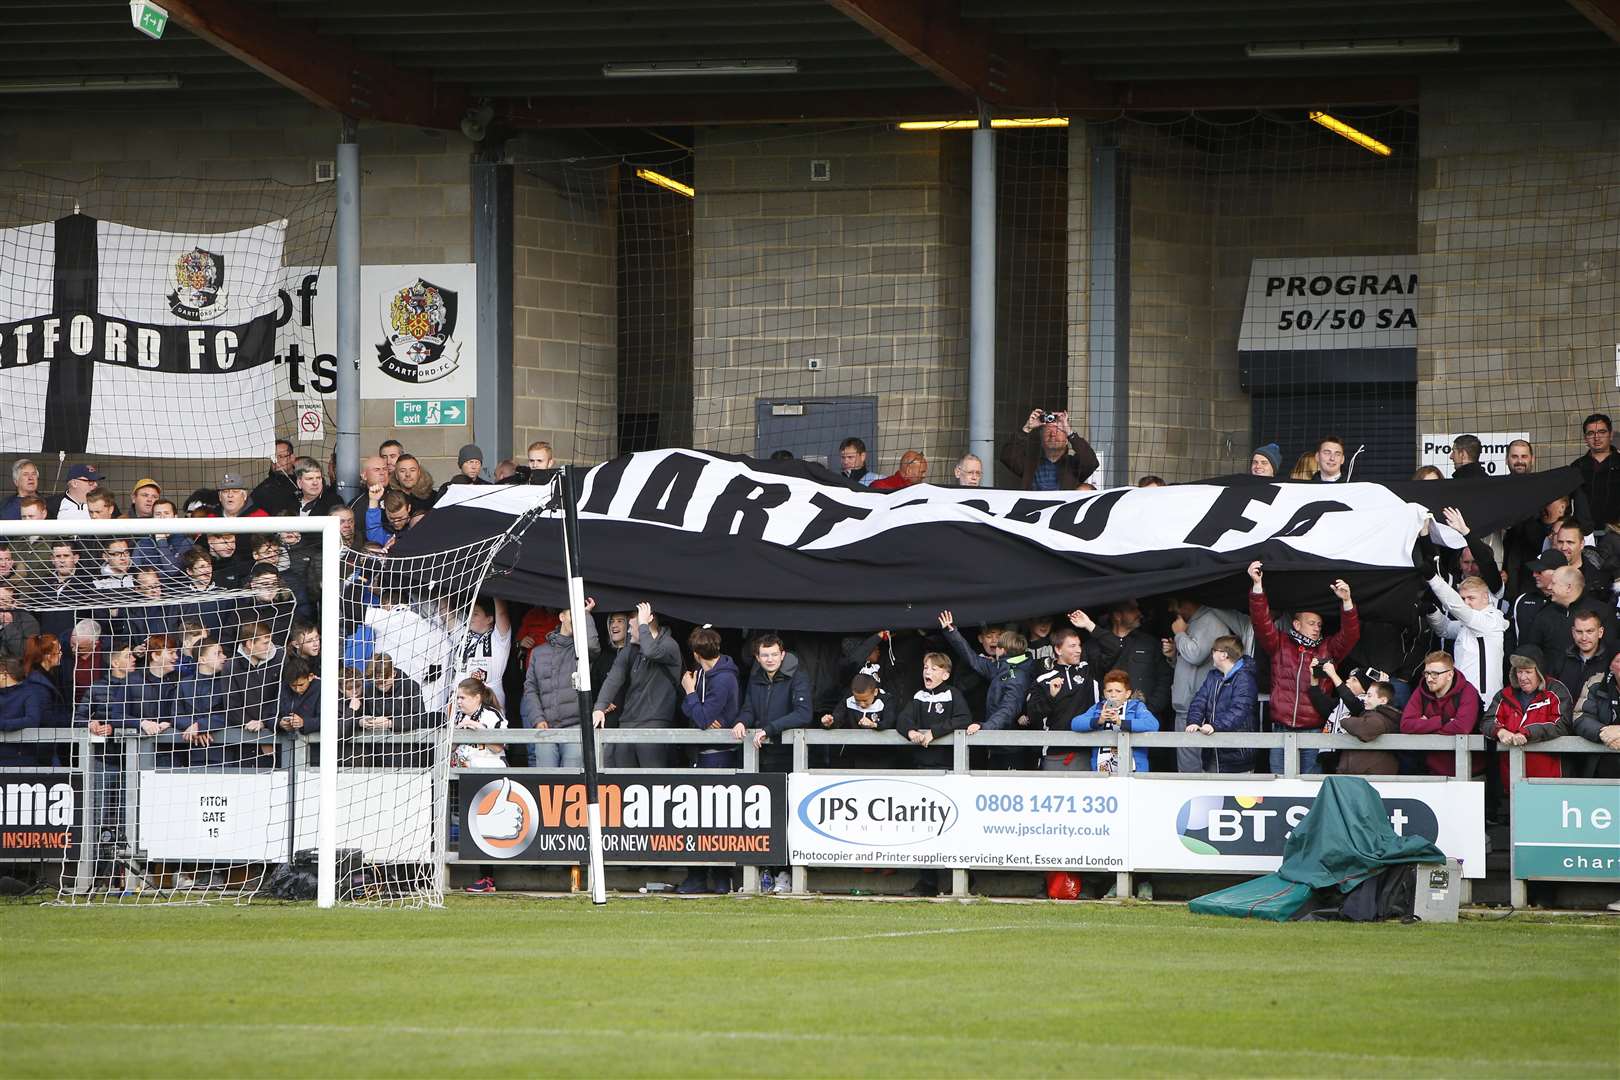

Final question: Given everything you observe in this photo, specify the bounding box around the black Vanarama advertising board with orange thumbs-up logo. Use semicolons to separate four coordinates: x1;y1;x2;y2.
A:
457;772;787;866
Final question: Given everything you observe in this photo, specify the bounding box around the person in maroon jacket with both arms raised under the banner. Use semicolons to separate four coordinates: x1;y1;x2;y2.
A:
1249;560;1361;776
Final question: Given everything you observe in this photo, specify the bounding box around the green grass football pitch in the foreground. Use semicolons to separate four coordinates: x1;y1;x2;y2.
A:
0;895;1620;1077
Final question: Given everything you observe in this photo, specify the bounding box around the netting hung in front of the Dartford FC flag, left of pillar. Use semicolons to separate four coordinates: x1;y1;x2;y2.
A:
0;172;335;512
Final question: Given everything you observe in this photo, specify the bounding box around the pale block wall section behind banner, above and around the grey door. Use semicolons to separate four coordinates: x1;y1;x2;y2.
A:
693;128;969;479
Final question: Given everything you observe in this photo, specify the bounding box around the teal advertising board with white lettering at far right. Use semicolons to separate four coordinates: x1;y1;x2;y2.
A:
1513;780;1620;881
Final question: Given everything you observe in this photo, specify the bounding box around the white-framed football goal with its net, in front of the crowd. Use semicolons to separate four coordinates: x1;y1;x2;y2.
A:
0;518;504;905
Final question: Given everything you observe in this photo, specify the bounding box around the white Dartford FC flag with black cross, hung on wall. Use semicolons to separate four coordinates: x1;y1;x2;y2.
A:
0;214;285;458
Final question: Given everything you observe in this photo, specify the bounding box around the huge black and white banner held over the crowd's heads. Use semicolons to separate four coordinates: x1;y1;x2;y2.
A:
395;450;1576;631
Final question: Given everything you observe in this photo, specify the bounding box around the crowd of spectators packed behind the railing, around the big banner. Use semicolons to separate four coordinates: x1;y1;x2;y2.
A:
0;410;1620;891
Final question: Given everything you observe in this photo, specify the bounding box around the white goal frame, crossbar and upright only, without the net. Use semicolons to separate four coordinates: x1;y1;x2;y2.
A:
0;517;341;908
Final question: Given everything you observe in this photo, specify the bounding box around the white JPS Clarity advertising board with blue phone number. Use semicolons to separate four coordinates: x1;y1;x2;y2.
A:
787;772;1129;870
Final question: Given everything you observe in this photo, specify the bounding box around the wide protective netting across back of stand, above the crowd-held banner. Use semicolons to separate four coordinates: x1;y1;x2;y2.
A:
518;108;1620;486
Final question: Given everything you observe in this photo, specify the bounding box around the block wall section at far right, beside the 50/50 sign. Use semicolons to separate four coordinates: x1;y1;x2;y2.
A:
1418;71;1620;468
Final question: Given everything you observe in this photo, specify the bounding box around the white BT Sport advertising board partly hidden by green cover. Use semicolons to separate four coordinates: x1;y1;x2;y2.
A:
1128;777;1486;878
